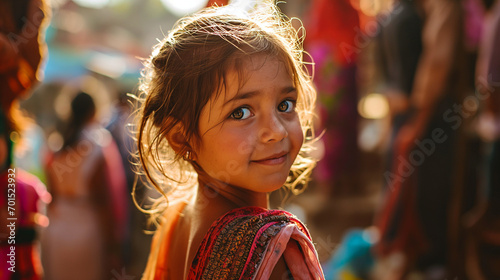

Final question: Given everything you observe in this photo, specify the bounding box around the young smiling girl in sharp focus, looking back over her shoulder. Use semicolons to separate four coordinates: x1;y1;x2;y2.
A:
137;1;324;279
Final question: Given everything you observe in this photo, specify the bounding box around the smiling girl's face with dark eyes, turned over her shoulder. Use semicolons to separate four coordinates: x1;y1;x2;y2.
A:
194;55;303;192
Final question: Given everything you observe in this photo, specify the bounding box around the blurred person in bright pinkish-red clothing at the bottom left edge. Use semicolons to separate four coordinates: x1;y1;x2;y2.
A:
0;109;51;280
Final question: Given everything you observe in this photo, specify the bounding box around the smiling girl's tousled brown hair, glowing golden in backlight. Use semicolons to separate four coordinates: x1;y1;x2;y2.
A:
136;1;316;217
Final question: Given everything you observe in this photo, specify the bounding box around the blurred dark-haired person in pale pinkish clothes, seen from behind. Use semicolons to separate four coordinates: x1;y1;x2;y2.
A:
42;92;127;280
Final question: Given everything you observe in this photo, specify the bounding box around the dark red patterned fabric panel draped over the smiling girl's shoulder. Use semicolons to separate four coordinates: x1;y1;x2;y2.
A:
188;207;310;279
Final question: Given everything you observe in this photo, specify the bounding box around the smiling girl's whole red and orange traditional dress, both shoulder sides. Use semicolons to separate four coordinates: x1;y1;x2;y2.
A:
143;203;324;280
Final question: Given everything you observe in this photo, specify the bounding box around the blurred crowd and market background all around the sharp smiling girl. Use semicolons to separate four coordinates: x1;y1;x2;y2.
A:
0;0;500;280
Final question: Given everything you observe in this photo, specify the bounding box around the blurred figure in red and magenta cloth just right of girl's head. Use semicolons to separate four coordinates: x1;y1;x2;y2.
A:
305;0;359;198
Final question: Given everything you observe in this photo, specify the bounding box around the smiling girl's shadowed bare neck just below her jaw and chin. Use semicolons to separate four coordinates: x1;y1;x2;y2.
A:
197;177;269;209
